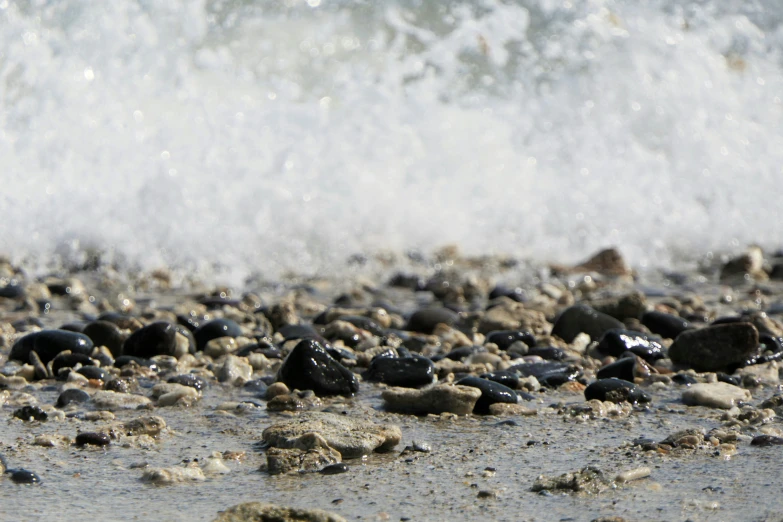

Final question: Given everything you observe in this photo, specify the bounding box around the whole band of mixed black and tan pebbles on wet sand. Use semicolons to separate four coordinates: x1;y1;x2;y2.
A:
0;247;783;520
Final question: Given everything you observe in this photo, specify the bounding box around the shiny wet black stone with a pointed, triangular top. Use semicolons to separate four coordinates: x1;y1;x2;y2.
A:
278;339;359;397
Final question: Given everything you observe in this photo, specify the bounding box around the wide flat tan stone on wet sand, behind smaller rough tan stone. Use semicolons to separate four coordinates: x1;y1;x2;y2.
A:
262;413;402;459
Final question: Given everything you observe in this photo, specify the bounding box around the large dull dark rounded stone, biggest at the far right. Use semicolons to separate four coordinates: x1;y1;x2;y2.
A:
669;323;759;372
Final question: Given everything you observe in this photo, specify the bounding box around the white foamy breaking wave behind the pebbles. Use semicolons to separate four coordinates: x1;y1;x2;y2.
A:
0;0;783;276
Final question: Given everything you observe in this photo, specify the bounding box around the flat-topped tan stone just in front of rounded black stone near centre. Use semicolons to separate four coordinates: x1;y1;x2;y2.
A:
381;384;481;415
